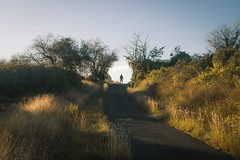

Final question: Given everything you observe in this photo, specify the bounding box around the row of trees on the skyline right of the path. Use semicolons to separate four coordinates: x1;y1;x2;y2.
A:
125;22;240;84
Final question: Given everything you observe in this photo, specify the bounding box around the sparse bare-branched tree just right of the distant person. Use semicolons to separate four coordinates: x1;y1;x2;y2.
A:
125;34;164;82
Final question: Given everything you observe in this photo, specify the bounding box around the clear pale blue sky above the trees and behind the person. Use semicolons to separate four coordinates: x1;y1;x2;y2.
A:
0;0;240;82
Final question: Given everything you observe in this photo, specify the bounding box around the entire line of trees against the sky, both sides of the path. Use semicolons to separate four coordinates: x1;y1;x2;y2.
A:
1;22;240;81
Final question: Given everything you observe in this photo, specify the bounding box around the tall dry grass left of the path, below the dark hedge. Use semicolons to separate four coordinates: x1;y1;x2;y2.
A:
0;83;132;160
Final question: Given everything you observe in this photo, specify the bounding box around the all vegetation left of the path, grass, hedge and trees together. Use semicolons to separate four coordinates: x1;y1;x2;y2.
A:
0;35;132;160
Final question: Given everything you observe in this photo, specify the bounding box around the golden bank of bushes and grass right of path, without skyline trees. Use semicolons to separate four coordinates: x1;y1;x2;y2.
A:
129;53;240;157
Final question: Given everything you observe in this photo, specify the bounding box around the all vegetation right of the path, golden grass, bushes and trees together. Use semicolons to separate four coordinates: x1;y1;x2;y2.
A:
126;23;240;157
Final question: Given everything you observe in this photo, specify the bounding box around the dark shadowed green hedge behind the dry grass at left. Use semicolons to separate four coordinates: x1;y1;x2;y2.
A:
0;66;80;98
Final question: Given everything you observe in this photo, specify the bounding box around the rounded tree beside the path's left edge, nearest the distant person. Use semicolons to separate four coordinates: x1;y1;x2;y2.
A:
80;40;118;81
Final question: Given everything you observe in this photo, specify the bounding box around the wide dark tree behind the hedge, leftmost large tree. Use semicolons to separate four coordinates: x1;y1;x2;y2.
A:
24;34;86;71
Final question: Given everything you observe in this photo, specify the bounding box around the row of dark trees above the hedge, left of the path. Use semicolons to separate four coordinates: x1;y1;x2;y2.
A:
0;33;118;81
